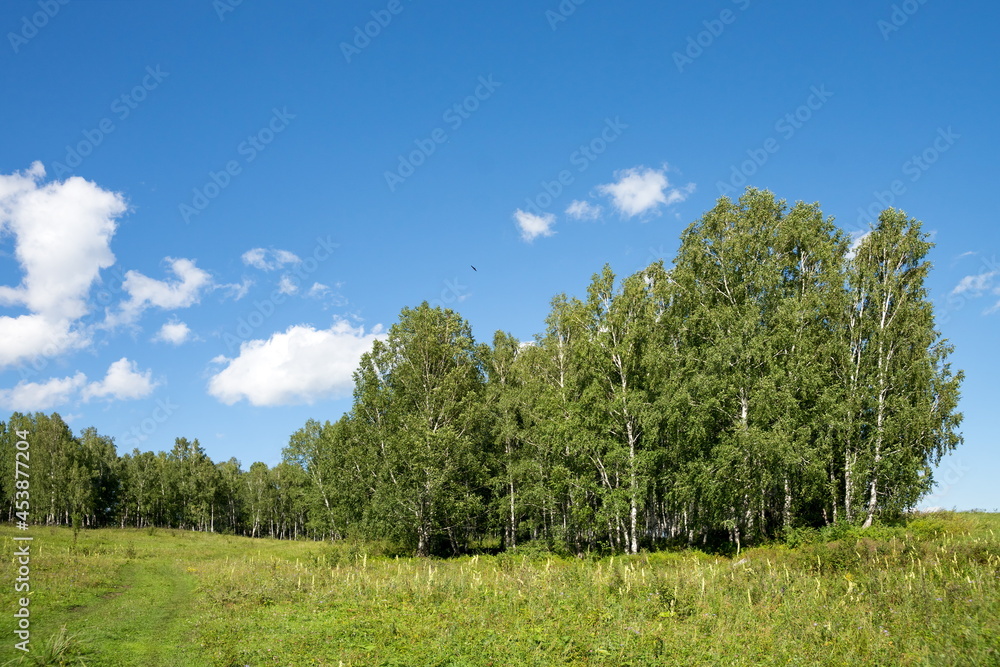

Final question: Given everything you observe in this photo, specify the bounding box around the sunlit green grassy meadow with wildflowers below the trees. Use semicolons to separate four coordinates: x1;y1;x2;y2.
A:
0;513;1000;667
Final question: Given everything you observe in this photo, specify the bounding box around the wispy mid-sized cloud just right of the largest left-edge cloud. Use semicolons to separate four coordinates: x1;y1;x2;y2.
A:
108;257;212;326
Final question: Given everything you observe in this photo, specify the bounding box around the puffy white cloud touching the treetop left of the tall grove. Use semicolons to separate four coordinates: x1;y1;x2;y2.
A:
208;320;385;406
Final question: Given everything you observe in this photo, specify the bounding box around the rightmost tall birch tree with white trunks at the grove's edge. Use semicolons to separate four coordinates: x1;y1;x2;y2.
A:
844;209;962;526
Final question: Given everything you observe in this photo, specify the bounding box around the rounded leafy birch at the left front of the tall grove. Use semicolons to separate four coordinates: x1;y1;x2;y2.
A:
355;302;488;556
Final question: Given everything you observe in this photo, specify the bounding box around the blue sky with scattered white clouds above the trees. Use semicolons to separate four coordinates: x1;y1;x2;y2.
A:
0;0;1000;509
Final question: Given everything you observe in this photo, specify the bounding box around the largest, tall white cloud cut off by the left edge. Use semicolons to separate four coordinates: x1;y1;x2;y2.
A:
0;162;126;367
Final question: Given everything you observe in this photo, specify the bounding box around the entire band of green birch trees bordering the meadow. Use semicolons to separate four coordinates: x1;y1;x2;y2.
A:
0;189;962;555
